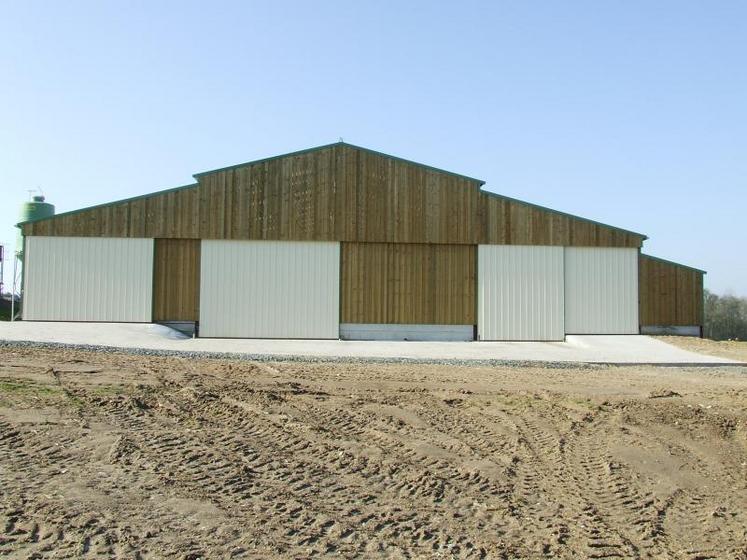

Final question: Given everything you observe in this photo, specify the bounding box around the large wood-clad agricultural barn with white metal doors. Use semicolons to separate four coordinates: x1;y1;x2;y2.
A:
19;142;703;340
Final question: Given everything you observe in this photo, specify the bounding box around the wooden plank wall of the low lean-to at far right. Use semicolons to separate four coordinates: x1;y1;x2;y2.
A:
638;255;703;327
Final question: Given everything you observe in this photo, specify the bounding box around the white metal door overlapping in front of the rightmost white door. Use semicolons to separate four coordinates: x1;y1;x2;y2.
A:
477;245;565;340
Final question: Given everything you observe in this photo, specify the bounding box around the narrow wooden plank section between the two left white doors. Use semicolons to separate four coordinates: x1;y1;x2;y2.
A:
153;239;200;321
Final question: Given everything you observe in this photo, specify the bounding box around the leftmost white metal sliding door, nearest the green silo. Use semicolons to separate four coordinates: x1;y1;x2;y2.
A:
23;236;153;323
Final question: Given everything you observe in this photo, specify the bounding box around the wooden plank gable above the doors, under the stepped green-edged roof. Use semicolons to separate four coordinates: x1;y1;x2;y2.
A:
24;143;645;247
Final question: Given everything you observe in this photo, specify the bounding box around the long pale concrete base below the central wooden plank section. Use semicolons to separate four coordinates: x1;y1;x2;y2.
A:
340;323;475;342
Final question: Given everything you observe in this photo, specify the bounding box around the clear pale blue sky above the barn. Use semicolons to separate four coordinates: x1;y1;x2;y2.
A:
0;0;747;296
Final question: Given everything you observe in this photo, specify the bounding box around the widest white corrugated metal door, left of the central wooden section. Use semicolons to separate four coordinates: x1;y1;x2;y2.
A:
200;240;340;338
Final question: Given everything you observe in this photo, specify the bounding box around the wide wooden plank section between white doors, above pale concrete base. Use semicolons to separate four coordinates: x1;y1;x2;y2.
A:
340;243;477;325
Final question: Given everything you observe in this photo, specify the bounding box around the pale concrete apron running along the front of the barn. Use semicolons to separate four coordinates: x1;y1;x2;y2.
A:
0;321;739;365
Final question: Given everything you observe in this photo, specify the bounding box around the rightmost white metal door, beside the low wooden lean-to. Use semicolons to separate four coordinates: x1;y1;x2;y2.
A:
565;247;638;334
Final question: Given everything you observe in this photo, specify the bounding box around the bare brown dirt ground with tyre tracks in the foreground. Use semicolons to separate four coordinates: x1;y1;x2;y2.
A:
0;348;747;559
